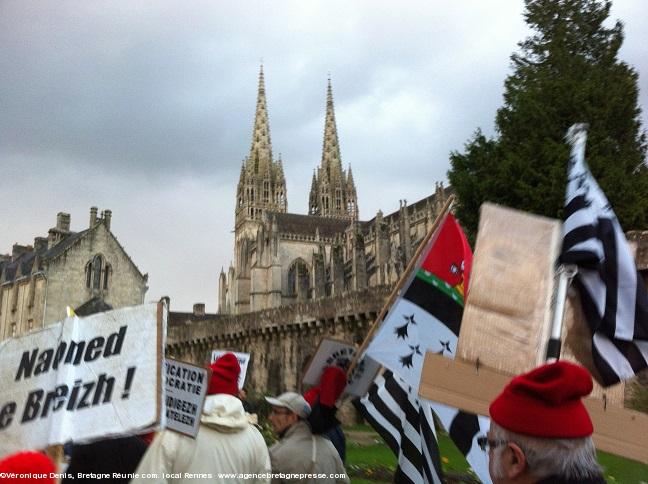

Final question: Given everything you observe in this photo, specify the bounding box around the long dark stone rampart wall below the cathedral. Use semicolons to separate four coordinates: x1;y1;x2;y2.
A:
167;286;391;394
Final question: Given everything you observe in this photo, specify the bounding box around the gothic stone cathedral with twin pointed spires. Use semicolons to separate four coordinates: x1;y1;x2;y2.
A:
218;67;447;315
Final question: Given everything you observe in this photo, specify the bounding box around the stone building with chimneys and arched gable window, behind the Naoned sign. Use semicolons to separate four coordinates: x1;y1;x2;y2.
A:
0;207;148;339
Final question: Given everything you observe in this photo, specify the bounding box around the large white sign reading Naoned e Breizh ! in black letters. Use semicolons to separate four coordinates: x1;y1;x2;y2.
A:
0;304;166;455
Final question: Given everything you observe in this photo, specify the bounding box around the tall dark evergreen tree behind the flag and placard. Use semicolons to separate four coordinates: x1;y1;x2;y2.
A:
448;0;648;238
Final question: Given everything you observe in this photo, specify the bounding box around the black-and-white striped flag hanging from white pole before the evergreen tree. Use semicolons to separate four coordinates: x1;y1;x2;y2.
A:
560;124;648;386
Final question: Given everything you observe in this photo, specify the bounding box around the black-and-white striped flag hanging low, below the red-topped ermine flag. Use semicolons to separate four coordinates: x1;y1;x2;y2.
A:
353;370;443;484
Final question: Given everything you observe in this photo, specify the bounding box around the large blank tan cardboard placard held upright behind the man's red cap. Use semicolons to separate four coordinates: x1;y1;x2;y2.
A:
457;203;624;406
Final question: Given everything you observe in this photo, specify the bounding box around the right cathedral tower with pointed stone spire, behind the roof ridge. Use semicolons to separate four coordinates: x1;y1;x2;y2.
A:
308;79;358;220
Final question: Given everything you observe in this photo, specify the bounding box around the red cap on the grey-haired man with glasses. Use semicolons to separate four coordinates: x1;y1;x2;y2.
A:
489;361;594;439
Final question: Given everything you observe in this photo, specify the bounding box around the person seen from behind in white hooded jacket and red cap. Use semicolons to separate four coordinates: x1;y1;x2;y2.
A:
131;353;271;484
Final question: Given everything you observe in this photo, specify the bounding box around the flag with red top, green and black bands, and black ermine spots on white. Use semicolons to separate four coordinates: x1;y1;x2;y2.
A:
365;214;472;394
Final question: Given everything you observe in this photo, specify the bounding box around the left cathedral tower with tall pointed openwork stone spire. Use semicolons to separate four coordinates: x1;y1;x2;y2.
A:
230;66;288;313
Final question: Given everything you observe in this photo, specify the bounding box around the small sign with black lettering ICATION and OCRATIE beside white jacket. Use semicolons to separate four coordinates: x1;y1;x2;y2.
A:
164;358;209;438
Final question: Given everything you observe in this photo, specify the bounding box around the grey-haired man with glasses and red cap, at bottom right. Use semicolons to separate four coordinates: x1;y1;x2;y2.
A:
486;361;605;484
